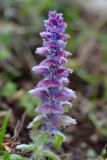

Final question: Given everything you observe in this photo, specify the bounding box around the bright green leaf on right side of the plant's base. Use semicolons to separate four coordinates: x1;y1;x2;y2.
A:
54;132;65;147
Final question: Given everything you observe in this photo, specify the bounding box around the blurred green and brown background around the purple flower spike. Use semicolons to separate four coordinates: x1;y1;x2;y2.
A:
0;0;107;160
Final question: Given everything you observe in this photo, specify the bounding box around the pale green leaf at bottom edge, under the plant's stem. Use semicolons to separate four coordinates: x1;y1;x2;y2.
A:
42;150;60;160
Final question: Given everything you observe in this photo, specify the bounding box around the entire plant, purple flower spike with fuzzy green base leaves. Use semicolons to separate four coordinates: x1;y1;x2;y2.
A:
17;11;76;160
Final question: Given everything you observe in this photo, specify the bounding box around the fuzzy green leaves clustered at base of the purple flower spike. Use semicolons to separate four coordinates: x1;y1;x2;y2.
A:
16;130;64;160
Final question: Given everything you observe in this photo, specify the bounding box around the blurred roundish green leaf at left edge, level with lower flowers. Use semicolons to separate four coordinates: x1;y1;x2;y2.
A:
1;82;17;97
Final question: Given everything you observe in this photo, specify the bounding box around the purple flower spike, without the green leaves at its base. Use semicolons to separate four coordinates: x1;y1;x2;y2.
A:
29;11;76;134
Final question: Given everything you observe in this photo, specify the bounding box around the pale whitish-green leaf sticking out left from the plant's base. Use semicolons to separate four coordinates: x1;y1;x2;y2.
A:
16;144;37;151
